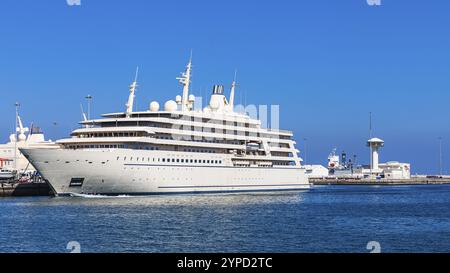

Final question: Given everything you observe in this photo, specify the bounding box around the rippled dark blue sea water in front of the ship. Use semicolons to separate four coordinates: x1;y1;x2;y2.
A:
0;185;450;252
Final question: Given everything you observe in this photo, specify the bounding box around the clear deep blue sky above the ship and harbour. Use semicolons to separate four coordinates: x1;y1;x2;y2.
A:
0;0;450;173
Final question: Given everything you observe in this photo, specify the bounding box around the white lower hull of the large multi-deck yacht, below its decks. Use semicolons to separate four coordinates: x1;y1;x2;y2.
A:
22;149;309;196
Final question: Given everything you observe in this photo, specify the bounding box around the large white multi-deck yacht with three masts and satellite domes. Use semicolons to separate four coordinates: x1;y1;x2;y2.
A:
21;57;310;195
